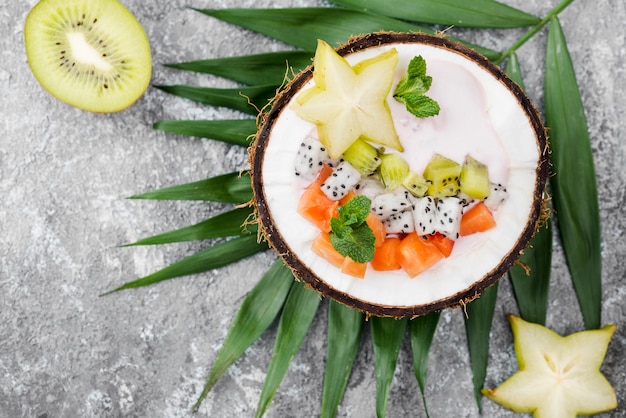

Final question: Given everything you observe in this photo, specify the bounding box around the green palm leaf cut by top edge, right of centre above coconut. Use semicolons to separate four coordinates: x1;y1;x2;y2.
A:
331;0;540;28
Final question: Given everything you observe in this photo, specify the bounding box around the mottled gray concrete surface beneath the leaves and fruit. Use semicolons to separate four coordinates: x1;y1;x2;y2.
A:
0;0;626;418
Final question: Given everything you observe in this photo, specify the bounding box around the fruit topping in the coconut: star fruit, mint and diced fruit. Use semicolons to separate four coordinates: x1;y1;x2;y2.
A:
294;41;507;278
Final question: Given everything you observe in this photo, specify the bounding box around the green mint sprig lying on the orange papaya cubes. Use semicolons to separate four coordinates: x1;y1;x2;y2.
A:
330;196;376;263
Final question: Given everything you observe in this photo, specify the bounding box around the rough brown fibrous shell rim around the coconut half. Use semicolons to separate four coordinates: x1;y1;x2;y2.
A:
250;32;550;318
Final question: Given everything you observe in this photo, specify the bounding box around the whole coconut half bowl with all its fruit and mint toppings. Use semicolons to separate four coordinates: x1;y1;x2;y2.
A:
251;32;548;316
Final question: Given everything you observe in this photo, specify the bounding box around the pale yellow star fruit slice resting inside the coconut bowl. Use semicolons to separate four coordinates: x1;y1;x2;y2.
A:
294;40;402;158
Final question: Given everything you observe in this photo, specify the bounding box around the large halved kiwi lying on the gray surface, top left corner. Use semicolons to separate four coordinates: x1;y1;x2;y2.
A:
24;0;152;113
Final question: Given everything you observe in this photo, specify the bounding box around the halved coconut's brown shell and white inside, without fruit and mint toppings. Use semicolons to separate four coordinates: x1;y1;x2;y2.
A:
251;32;549;317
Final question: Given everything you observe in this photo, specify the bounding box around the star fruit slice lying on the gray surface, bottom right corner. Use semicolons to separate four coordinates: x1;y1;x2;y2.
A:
483;315;617;418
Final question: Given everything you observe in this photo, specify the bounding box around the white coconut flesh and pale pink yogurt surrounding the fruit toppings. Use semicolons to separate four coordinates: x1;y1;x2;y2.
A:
255;33;545;315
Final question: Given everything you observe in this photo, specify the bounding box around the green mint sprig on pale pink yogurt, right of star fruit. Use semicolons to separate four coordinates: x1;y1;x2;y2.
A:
393;55;440;118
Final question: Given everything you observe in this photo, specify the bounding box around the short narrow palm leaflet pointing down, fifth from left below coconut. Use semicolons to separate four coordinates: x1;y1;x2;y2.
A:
409;312;441;417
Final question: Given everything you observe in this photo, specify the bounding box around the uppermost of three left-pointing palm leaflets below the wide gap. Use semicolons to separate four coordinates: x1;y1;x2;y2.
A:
130;172;252;203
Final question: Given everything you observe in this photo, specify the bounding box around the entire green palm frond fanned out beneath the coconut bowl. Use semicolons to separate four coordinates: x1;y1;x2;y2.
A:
119;0;601;416
